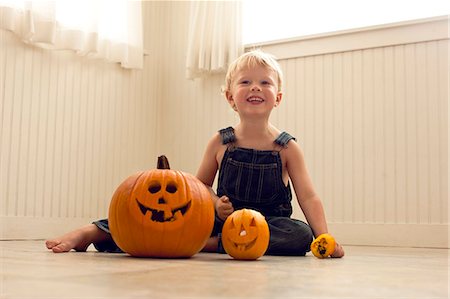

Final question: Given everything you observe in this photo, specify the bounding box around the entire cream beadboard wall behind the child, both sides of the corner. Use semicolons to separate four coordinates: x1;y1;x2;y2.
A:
0;1;448;247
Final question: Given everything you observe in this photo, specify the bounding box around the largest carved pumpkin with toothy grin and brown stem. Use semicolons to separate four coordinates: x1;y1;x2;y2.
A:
109;156;214;258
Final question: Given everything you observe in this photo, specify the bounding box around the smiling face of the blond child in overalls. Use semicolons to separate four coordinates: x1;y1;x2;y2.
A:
225;64;282;116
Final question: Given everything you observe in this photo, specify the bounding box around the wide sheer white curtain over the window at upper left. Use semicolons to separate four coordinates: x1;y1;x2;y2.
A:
0;0;143;68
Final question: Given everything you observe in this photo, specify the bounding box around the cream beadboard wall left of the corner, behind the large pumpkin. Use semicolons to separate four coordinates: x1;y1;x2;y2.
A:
0;1;162;239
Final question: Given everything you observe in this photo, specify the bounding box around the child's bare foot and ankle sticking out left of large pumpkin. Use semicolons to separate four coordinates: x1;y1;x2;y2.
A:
45;224;111;253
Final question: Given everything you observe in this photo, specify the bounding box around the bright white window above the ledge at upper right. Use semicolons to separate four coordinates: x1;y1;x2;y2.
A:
242;0;450;44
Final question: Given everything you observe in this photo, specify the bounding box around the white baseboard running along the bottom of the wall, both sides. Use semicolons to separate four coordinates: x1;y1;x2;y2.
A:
0;216;450;248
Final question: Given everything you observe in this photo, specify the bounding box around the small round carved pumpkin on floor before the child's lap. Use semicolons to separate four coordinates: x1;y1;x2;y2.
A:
222;209;270;260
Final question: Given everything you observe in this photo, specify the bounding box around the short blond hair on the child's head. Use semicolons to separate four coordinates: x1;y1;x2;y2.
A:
223;49;283;92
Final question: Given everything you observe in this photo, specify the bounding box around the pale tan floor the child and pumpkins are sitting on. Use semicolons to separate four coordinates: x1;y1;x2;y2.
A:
0;241;449;299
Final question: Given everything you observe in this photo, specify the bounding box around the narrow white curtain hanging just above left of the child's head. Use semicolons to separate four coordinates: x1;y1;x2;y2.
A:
186;1;243;79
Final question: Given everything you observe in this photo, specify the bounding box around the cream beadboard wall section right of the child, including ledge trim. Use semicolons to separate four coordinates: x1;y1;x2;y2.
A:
263;19;449;247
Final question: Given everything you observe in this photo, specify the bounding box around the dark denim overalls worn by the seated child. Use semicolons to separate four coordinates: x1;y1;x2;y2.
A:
213;127;313;255
